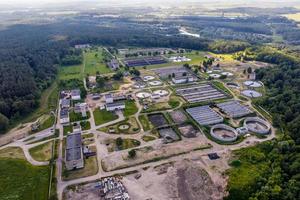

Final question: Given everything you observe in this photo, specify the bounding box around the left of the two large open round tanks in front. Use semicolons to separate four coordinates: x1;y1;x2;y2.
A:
210;124;238;142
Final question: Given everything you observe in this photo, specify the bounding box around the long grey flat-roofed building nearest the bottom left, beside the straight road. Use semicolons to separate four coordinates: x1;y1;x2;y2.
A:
65;132;84;170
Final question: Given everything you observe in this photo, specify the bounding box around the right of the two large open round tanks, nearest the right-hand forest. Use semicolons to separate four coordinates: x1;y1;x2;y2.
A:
244;117;271;135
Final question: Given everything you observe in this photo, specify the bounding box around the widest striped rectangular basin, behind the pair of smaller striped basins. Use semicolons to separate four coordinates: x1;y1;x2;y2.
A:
176;83;227;103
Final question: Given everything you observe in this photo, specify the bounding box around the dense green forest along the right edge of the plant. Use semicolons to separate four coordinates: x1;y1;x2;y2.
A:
228;48;300;200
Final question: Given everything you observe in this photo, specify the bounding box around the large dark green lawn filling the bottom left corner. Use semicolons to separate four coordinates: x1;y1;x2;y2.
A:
0;158;50;200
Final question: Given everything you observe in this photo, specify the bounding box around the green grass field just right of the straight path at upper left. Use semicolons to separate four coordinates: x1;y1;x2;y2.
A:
84;48;112;75
